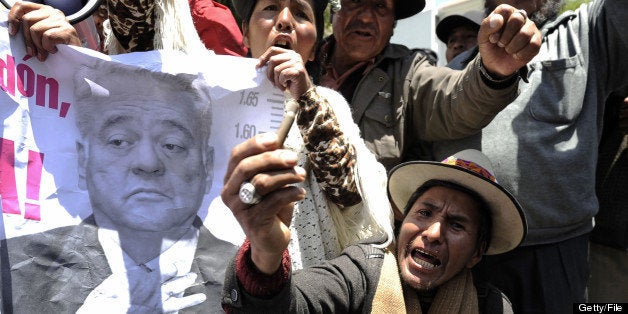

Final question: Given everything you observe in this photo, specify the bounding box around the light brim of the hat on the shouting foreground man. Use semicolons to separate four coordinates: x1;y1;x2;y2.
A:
388;161;527;255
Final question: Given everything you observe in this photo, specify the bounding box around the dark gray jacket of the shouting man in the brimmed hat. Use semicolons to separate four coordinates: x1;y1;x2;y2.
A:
222;239;512;313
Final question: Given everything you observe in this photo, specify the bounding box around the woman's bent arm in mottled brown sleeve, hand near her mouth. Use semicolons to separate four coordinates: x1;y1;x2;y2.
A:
258;47;362;207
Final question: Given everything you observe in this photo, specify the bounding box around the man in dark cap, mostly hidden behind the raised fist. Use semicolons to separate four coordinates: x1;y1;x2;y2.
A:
436;10;484;63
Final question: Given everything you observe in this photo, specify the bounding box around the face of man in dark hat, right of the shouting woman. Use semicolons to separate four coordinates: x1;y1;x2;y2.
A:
333;0;395;62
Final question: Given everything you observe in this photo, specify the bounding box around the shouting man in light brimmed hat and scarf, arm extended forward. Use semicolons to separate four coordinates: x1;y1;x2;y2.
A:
223;150;526;313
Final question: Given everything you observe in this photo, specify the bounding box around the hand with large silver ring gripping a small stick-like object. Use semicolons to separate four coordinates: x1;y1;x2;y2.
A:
220;133;305;274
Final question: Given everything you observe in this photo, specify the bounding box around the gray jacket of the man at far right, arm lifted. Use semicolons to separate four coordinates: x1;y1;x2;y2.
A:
433;0;628;245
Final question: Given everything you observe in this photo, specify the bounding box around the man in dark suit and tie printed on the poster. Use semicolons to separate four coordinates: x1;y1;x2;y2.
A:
0;60;237;313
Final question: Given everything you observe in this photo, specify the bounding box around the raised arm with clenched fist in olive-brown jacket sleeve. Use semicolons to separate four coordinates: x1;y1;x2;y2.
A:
409;5;541;141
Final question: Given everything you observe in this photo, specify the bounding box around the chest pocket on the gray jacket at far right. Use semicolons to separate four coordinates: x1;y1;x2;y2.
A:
521;55;587;124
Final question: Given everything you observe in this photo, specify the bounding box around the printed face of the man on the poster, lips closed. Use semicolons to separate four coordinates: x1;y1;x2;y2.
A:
78;95;211;231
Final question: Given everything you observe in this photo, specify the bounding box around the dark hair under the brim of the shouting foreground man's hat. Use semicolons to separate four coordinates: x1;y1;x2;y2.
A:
403;179;493;253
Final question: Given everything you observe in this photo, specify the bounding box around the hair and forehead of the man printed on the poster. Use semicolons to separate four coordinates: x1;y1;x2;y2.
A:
75;67;211;135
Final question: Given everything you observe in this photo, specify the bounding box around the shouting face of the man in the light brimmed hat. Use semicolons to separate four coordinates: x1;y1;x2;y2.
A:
397;186;482;291
